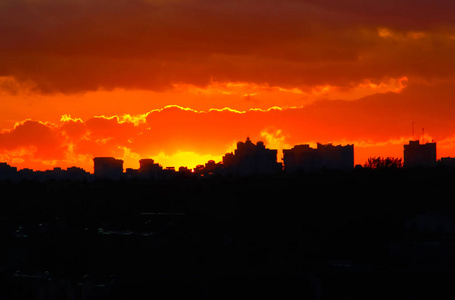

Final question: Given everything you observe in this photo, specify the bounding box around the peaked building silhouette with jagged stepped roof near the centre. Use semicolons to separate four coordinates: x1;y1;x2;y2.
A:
223;137;282;176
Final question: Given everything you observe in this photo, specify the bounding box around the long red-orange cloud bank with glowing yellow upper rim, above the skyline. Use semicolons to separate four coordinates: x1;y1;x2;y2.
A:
0;84;455;170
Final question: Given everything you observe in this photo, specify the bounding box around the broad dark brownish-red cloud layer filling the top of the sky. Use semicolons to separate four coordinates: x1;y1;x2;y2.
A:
0;0;455;93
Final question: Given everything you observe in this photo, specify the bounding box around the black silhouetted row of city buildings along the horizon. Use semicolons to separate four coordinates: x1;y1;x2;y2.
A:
0;137;448;180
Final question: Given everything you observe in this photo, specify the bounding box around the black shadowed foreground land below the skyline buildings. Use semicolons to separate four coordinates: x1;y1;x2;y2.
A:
0;169;455;300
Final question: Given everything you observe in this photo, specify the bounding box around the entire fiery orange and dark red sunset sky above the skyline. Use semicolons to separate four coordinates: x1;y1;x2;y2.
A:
0;0;455;172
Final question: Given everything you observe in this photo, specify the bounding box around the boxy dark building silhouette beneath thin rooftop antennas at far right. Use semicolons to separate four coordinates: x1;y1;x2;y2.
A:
403;140;436;168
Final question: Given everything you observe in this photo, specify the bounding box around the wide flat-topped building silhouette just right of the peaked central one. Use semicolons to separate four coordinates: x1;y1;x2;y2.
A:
283;143;354;172
